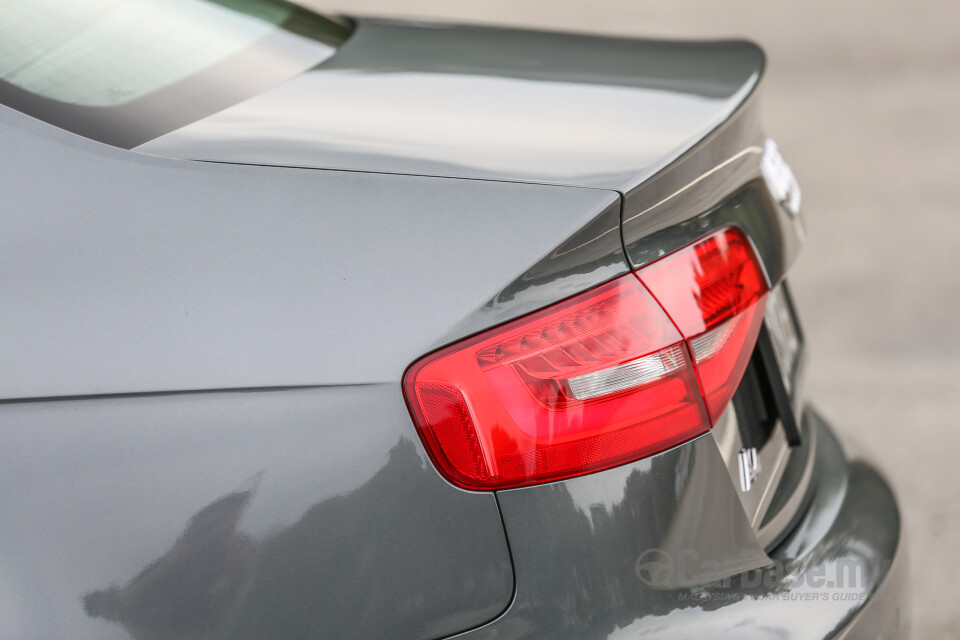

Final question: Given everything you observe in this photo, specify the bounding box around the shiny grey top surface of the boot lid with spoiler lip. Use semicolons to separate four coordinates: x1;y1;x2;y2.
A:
138;20;763;190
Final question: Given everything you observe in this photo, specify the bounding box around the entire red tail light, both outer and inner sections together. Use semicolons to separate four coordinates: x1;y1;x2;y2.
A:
404;229;767;489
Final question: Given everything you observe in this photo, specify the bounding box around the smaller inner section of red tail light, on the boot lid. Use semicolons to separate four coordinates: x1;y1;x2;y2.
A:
637;228;769;424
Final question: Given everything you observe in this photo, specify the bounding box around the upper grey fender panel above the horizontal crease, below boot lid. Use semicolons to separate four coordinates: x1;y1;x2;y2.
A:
0;108;627;399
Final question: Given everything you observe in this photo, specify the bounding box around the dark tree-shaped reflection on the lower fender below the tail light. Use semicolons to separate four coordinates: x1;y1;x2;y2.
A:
82;440;508;640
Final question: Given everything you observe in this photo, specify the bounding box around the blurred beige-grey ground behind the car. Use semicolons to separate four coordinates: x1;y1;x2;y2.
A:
310;0;960;638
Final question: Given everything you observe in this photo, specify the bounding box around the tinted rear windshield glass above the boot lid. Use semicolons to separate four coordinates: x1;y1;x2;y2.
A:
0;0;351;148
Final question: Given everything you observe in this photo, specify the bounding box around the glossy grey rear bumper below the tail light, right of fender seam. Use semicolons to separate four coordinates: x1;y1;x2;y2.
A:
462;410;909;640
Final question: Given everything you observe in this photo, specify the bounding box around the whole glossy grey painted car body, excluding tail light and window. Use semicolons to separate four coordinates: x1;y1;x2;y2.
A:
0;5;908;640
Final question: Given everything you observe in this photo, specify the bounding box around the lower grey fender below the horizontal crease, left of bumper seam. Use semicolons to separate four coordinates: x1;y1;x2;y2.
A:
0;385;512;640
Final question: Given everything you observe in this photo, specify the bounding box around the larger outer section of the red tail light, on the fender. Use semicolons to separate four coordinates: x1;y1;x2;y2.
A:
404;275;709;489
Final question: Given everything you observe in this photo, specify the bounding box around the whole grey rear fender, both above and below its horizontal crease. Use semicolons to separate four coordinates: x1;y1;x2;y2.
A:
0;102;627;638
